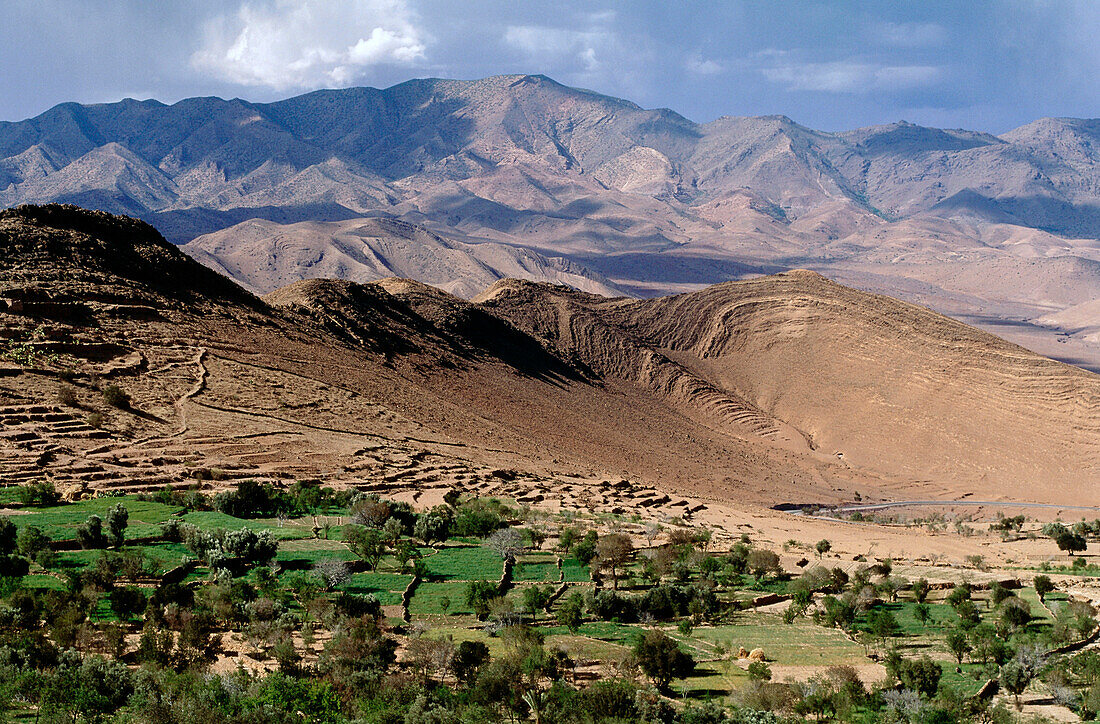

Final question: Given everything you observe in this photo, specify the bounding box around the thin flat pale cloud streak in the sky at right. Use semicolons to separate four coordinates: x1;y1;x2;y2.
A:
760;61;943;94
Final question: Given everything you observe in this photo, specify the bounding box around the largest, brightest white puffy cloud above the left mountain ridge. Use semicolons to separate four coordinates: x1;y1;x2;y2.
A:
191;0;427;90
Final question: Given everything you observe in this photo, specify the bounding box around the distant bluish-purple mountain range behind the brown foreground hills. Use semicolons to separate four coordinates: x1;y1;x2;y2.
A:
0;76;1100;369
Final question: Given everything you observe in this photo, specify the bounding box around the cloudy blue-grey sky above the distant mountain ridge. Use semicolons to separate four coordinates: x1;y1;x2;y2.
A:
0;0;1100;132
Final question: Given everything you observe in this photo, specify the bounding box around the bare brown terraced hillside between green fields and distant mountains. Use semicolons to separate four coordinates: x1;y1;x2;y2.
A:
0;206;1100;503
